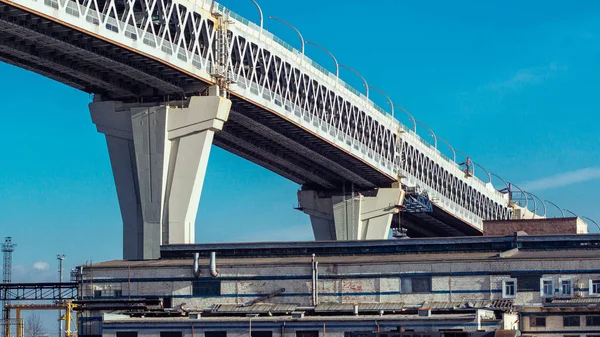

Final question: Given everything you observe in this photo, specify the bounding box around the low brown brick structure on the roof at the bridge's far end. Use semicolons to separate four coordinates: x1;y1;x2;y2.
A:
483;218;588;236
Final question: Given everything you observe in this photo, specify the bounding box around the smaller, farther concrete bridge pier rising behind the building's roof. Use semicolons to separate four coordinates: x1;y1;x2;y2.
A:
298;186;404;240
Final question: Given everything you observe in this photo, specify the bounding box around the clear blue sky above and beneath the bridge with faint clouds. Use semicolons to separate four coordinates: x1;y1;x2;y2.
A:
0;0;600;281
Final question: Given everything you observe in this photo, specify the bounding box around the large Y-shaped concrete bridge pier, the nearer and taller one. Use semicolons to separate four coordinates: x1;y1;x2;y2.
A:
89;90;231;260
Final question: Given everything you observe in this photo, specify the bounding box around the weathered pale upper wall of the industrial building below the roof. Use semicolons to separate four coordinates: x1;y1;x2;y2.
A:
83;256;600;308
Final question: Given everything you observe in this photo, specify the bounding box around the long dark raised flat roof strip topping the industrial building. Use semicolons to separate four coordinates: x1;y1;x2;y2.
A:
161;234;600;259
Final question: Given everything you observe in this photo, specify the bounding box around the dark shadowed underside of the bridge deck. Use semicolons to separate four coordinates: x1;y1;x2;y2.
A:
0;2;393;190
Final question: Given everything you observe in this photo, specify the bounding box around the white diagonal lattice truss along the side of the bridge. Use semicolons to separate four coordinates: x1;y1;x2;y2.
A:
0;0;510;225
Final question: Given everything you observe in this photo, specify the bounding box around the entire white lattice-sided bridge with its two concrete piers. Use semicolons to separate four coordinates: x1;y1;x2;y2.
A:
0;0;545;259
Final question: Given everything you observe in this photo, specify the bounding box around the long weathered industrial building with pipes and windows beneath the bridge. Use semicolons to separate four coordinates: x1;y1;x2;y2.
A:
68;232;600;337
